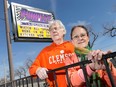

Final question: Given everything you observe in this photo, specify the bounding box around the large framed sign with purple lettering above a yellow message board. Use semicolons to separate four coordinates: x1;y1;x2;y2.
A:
11;2;54;42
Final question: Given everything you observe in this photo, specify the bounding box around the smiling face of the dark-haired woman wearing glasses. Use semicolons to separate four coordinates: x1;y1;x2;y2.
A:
72;27;89;47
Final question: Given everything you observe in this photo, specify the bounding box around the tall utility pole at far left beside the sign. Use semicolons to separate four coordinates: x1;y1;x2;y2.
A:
4;0;14;82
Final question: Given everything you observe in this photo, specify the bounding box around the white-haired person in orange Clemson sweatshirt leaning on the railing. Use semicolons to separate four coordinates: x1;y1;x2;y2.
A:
29;20;74;87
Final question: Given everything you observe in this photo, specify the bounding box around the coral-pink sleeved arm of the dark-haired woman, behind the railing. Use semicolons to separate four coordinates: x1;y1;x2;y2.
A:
65;54;94;87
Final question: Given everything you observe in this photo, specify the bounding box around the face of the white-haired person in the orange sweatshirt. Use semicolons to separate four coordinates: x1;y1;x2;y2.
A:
49;23;65;41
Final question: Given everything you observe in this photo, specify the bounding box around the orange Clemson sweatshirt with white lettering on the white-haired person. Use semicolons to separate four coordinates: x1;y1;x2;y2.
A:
29;41;74;87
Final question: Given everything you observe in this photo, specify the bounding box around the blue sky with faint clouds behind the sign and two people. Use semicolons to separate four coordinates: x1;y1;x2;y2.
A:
0;0;116;77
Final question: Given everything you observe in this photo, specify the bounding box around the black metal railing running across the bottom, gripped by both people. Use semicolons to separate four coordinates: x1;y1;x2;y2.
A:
0;52;116;87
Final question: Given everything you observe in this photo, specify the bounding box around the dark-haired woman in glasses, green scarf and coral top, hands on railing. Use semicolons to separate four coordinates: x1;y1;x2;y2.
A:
65;25;116;87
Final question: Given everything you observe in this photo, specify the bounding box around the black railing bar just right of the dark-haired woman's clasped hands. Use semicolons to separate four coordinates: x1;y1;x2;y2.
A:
103;58;116;87
